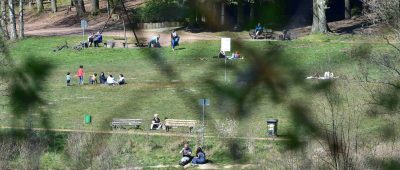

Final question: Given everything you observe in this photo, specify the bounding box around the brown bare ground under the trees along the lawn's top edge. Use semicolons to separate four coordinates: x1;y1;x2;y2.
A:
25;0;372;46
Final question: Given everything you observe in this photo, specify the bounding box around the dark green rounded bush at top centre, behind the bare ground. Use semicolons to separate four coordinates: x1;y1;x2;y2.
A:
133;0;188;22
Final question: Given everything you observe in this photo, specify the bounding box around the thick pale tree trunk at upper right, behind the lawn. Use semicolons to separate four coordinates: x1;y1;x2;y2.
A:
311;0;328;33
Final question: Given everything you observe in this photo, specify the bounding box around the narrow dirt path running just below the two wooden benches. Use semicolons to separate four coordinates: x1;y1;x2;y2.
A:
0;126;287;141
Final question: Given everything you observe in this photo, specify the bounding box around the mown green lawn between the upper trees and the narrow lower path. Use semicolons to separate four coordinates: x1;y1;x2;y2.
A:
0;37;394;137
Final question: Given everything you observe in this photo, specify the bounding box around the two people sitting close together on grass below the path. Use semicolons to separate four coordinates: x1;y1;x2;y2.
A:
179;143;207;166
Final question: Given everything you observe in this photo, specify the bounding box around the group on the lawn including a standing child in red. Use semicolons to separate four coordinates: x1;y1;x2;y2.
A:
66;65;126;86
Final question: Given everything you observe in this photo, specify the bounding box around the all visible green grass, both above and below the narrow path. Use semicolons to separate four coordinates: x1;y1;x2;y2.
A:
0;36;398;167
